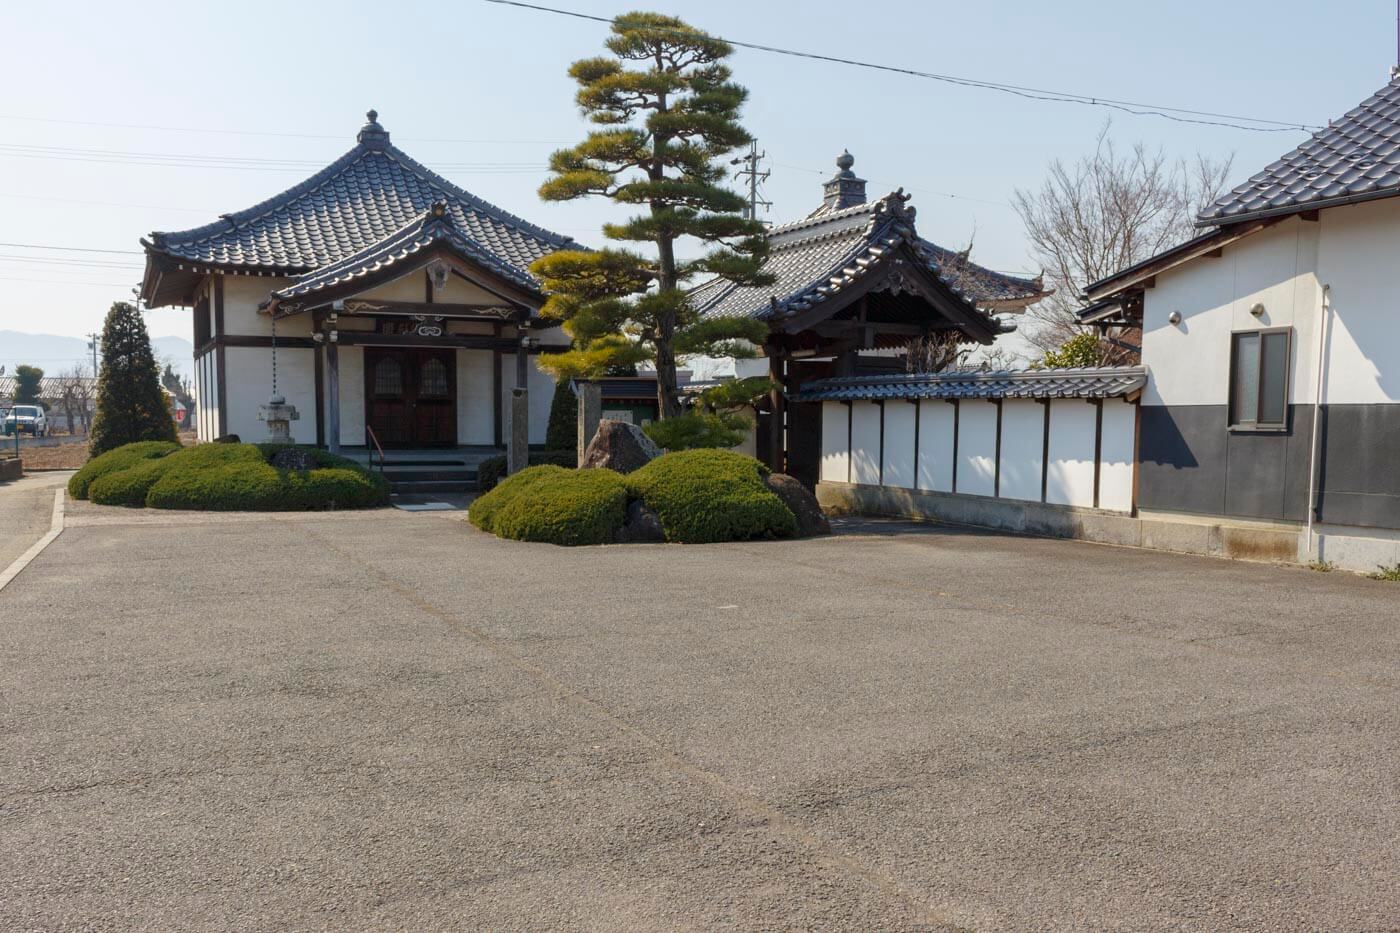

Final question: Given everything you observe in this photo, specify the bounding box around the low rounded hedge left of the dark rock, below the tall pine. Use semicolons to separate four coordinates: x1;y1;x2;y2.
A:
468;465;627;545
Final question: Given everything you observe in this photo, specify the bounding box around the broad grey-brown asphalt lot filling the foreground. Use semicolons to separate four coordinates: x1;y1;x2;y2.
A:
0;507;1400;930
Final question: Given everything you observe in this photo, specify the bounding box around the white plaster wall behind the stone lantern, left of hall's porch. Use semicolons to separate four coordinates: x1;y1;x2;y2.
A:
224;346;316;444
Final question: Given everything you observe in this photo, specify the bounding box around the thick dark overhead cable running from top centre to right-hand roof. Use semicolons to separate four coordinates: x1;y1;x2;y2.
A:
486;0;1323;133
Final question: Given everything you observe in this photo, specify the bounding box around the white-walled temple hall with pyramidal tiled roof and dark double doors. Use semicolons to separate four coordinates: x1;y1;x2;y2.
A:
141;111;573;450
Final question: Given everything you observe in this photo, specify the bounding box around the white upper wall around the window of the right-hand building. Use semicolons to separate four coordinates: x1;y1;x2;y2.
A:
1142;217;1327;405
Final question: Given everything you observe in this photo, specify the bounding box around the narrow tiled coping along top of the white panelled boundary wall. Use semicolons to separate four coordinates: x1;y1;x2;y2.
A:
797;366;1147;402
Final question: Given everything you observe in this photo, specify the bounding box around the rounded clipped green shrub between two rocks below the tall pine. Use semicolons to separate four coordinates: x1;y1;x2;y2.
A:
627;450;797;544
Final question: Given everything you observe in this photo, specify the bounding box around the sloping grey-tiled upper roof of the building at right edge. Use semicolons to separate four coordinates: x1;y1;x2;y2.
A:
1196;80;1400;227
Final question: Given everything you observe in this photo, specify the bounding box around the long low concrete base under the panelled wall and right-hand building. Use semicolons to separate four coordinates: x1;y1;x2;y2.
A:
816;482;1400;573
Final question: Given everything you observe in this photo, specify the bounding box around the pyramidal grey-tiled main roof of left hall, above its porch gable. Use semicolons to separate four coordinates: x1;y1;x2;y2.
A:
143;111;571;301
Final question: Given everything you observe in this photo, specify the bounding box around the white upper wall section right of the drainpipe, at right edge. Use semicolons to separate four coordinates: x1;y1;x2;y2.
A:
1306;199;1400;405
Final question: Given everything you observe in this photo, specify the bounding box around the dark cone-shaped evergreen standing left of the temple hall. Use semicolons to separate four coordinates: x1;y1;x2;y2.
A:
90;301;176;457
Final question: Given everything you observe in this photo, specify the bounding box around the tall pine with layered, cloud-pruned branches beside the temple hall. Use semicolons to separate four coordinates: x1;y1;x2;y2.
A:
532;13;771;419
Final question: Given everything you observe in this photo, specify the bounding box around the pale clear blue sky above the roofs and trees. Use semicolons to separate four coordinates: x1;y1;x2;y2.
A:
0;0;1396;343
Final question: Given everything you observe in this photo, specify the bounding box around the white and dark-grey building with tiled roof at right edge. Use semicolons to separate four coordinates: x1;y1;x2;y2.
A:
1081;80;1400;570
